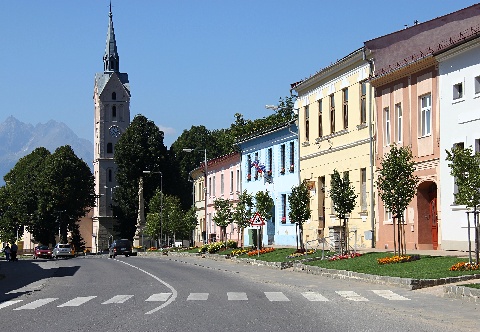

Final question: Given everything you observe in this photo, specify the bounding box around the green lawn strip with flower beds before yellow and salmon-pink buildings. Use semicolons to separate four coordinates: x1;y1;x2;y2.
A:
306;252;480;279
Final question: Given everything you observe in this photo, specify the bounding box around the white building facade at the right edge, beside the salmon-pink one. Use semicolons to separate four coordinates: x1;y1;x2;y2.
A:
435;34;480;251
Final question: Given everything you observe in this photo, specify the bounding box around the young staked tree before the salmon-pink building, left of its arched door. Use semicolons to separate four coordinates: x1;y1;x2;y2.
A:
376;144;418;255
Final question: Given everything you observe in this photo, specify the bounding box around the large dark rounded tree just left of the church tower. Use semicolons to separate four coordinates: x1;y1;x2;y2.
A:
36;145;95;243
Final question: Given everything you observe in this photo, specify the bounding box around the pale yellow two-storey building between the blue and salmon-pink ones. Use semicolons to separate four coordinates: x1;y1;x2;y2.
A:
293;48;375;249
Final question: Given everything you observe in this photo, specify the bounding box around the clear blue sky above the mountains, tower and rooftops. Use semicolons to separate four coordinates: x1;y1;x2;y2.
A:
0;0;476;147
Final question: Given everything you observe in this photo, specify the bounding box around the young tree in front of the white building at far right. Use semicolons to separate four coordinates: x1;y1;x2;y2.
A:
446;146;480;264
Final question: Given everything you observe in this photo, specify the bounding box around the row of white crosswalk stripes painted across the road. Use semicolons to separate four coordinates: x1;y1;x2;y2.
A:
0;290;410;311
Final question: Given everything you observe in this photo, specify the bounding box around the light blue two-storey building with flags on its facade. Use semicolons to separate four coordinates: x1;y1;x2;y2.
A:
237;121;300;246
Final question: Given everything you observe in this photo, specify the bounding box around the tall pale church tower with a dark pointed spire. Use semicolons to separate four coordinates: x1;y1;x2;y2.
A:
92;3;130;252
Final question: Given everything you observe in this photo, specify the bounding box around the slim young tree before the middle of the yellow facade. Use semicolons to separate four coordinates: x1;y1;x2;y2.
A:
330;169;358;255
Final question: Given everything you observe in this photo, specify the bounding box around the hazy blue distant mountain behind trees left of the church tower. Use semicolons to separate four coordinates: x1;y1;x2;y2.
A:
0;116;93;185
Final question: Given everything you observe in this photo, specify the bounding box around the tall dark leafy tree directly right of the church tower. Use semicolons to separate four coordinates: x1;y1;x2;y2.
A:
113;115;168;239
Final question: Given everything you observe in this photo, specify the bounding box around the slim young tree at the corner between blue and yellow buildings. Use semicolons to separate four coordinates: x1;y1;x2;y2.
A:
288;180;312;252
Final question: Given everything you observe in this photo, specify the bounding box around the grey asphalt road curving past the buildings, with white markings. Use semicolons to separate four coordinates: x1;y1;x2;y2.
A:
0;256;480;332
